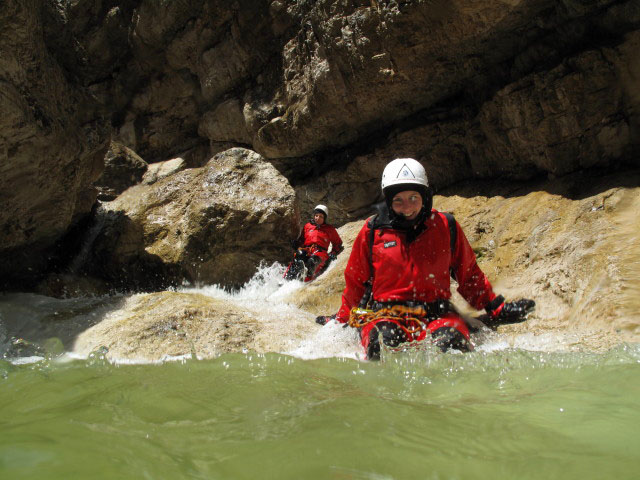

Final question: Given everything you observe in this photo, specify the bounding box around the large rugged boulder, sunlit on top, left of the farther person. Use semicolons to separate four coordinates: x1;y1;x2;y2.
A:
85;148;299;288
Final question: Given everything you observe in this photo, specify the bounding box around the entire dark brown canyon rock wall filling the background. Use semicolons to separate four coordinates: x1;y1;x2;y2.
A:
0;0;640;286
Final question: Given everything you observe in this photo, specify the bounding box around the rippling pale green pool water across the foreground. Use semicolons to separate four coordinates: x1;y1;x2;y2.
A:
0;345;640;480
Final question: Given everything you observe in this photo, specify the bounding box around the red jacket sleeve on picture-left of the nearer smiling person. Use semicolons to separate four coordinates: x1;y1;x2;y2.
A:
336;223;371;323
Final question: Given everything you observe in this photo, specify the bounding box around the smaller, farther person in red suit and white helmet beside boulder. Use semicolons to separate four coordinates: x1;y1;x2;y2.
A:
284;205;343;282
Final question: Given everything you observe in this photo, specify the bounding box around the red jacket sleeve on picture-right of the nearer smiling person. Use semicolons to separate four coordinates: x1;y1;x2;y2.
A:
451;222;496;310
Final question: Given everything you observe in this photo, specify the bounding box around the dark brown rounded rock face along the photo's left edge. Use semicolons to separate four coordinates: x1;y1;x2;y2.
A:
0;0;109;284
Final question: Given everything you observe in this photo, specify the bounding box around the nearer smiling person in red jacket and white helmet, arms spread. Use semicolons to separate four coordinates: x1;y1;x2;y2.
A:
318;158;535;359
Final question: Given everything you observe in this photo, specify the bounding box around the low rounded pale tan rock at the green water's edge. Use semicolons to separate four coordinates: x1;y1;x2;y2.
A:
73;292;317;361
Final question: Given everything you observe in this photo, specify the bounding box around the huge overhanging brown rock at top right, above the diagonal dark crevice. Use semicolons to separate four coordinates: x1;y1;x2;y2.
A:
245;0;640;163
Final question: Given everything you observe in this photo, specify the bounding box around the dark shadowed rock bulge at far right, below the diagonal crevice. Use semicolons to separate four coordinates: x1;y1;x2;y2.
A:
468;47;633;178
